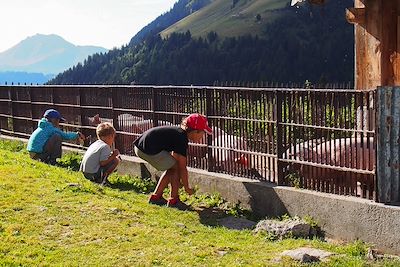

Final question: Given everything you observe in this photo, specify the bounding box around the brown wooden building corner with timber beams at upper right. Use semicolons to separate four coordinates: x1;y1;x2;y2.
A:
346;0;400;90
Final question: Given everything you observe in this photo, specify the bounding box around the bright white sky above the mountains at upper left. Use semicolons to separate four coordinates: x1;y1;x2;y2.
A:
0;0;178;52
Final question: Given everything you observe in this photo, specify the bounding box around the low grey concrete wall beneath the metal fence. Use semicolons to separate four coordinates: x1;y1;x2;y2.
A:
2;137;400;254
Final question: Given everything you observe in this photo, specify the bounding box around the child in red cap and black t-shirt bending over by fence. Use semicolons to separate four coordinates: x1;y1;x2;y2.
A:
134;114;212;208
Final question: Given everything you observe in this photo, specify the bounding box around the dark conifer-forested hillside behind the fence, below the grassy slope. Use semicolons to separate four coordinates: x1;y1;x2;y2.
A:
51;0;354;85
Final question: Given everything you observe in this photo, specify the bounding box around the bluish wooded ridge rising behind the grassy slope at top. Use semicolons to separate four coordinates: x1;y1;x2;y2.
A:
129;0;212;46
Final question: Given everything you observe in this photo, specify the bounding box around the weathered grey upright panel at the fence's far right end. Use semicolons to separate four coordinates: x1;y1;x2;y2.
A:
376;87;400;204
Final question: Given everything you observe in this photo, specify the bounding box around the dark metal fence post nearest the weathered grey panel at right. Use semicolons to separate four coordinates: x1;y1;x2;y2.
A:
275;90;285;185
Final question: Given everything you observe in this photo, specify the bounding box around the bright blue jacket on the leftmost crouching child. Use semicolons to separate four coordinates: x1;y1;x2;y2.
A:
27;118;78;153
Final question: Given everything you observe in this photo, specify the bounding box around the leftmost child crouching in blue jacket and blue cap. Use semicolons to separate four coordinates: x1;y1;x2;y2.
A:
27;109;85;165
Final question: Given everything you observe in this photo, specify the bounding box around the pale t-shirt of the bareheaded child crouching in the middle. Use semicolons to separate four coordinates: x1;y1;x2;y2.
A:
80;140;112;173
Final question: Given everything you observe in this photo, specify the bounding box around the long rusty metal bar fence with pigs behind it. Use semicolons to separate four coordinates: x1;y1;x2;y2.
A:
0;86;376;199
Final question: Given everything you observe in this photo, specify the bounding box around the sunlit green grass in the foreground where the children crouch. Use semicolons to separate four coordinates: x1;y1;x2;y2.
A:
0;141;396;266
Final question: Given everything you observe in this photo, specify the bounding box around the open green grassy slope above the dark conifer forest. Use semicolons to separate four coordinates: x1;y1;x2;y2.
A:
162;0;288;37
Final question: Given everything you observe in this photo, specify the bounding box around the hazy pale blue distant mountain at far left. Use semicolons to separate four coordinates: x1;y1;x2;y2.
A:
0;34;107;74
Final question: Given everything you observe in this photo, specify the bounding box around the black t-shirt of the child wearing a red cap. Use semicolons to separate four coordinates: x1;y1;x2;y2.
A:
133;126;189;157
